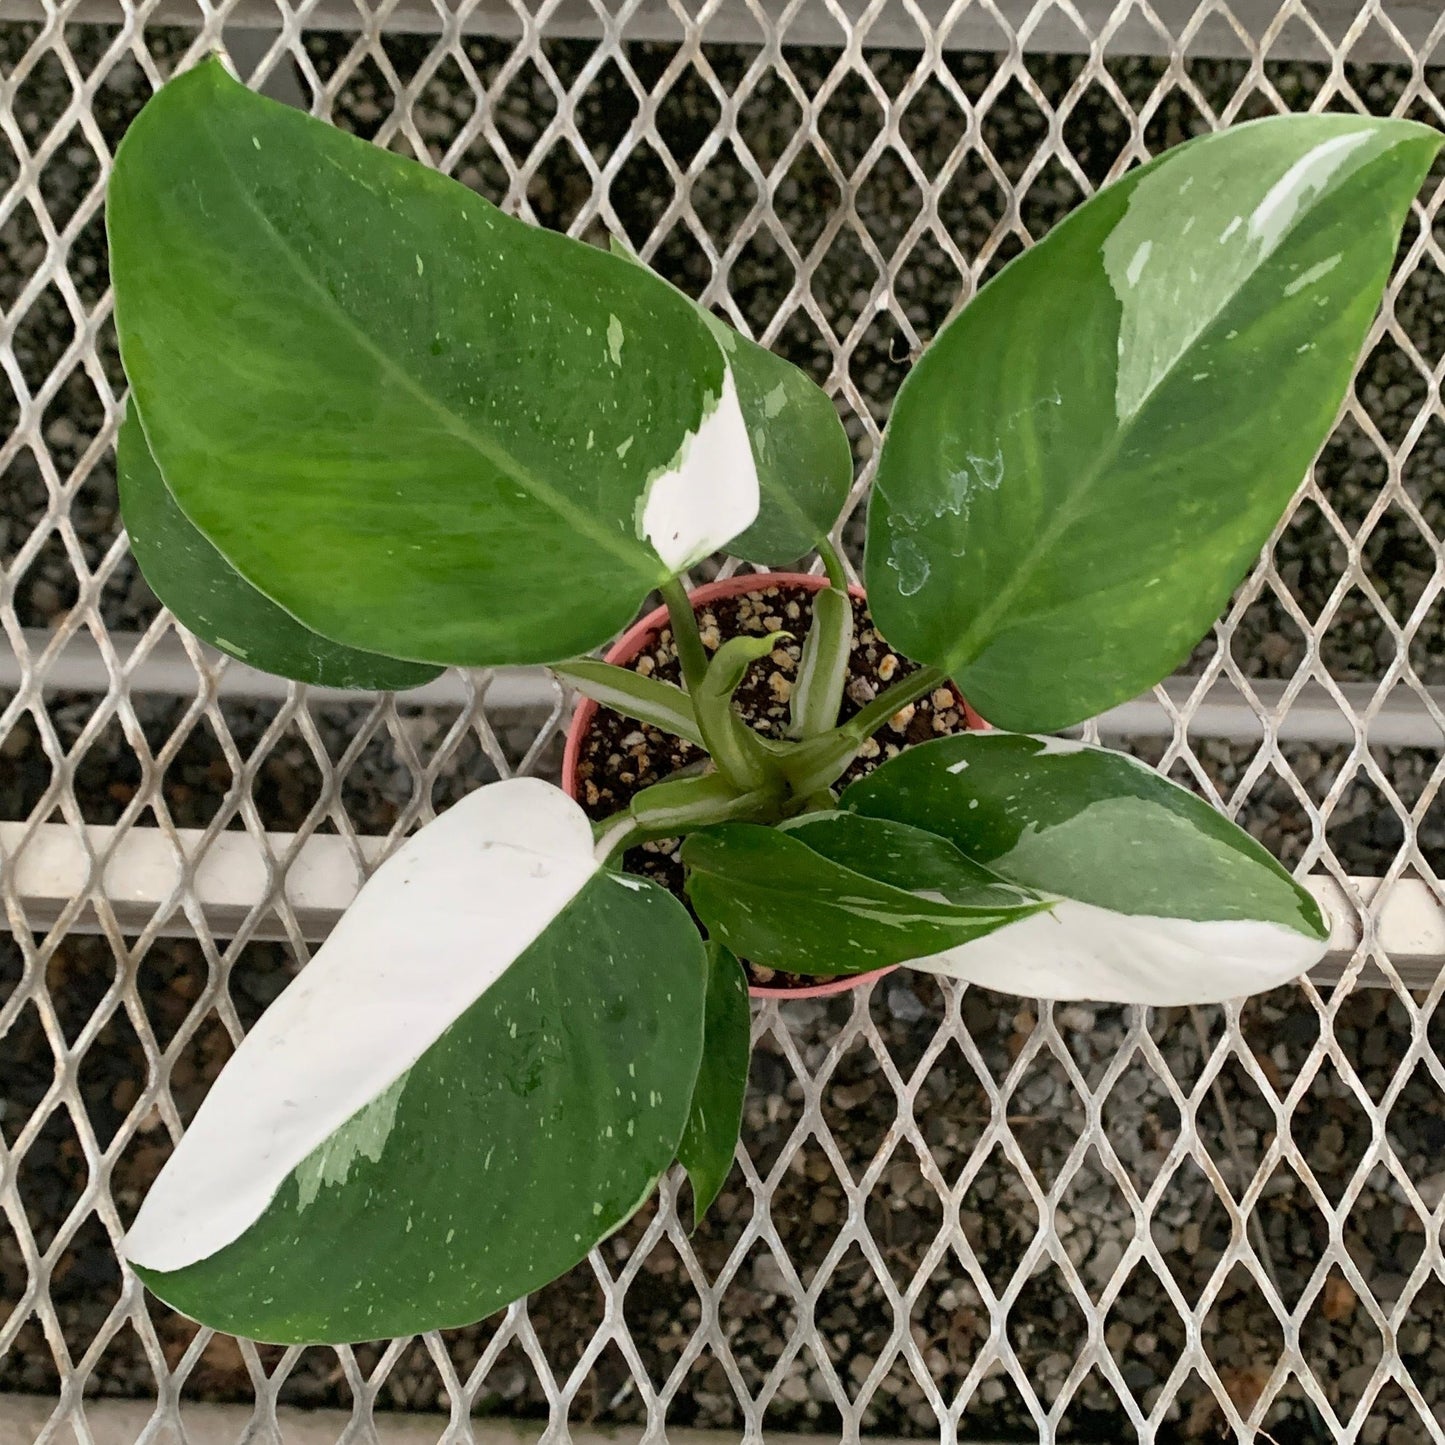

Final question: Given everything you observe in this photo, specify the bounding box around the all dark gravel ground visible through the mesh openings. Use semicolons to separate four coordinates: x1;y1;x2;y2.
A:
0;14;1445;1445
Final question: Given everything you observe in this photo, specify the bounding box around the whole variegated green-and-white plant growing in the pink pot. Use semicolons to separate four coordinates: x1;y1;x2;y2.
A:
108;61;1439;1341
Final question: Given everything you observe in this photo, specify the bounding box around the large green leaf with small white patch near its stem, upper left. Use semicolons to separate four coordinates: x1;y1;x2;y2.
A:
107;61;757;665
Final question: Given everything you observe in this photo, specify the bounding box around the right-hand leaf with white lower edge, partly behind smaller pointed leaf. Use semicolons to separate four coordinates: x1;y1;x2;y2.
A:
840;733;1329;1004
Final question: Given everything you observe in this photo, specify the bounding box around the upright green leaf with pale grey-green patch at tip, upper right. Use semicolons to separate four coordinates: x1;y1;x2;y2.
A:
866;114;1441;731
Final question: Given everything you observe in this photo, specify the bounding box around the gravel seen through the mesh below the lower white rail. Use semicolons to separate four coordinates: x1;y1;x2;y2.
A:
8;938;1445;1445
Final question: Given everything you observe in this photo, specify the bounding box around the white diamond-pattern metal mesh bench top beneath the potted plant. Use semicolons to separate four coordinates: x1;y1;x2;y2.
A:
8;0;1445;1445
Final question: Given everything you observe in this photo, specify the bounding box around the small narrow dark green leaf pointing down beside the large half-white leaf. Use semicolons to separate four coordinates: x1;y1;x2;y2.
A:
678;944;753;1228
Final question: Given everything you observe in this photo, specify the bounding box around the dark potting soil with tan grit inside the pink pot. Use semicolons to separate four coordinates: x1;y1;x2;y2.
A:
577;578;968;988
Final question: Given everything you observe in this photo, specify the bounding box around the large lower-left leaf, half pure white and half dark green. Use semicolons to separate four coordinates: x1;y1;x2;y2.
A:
124;779;705;1344
